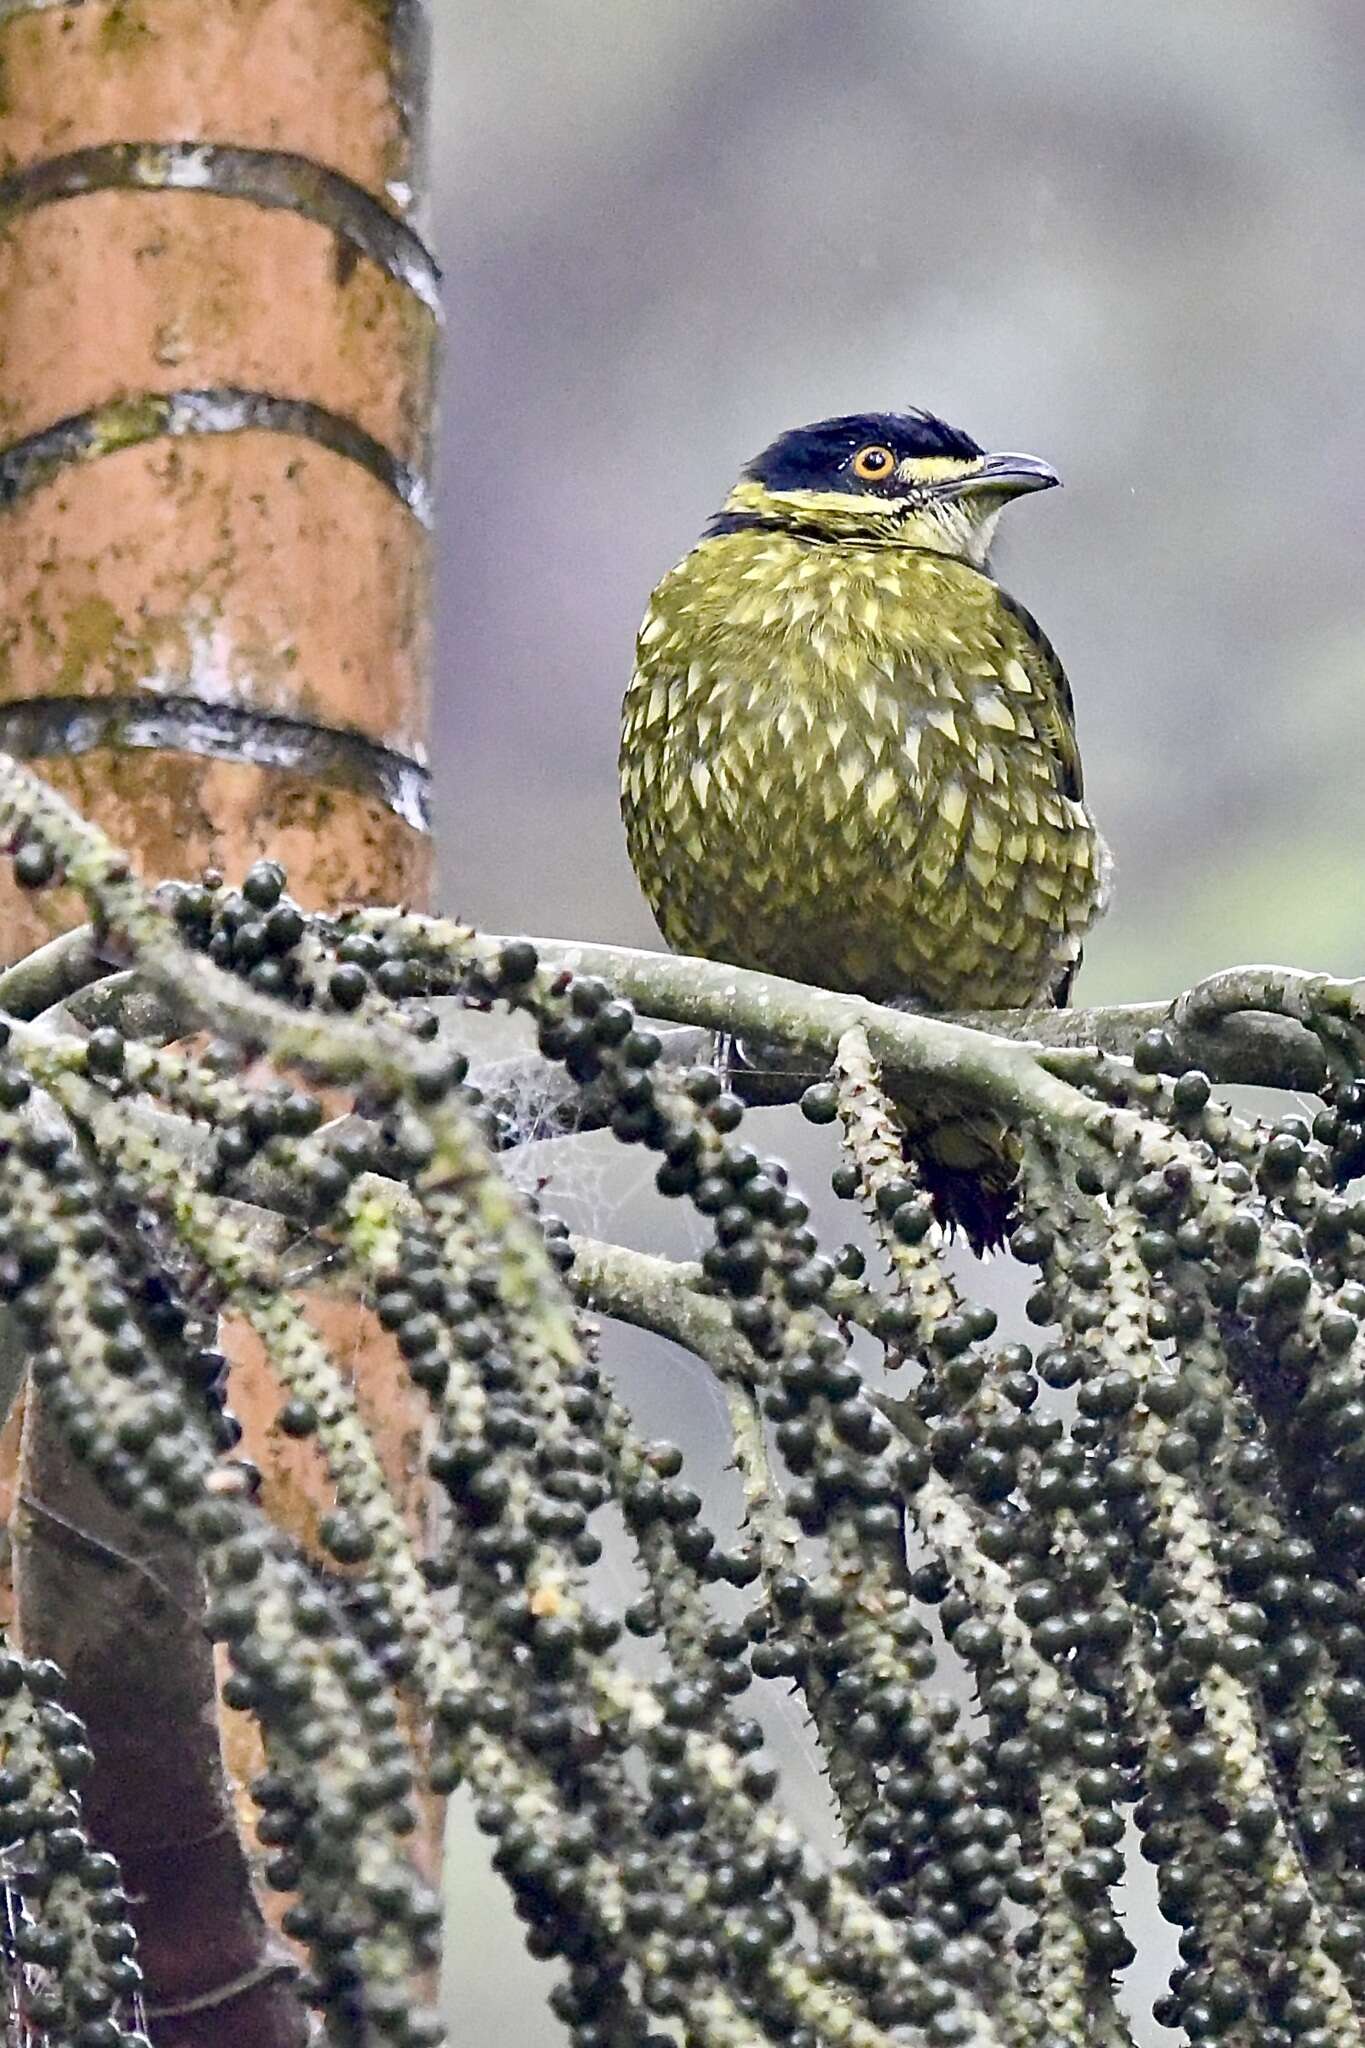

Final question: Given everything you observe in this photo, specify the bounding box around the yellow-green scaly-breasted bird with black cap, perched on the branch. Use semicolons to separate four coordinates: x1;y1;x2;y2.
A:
620;410;1111;1251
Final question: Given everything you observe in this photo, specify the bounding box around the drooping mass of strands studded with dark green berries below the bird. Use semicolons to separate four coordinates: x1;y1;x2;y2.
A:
0;770;1365;2048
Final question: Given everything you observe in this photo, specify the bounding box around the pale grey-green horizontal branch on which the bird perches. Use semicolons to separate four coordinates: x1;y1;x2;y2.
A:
0;928;1342;1171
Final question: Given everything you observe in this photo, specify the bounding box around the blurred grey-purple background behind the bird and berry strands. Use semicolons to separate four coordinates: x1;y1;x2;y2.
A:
432;0;1365;2048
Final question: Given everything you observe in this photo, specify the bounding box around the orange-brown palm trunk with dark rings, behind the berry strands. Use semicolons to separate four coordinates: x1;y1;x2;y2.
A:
0;0;438;2048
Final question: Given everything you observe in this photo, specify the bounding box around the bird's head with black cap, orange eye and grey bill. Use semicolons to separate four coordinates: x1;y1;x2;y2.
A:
706;412;1062;567
